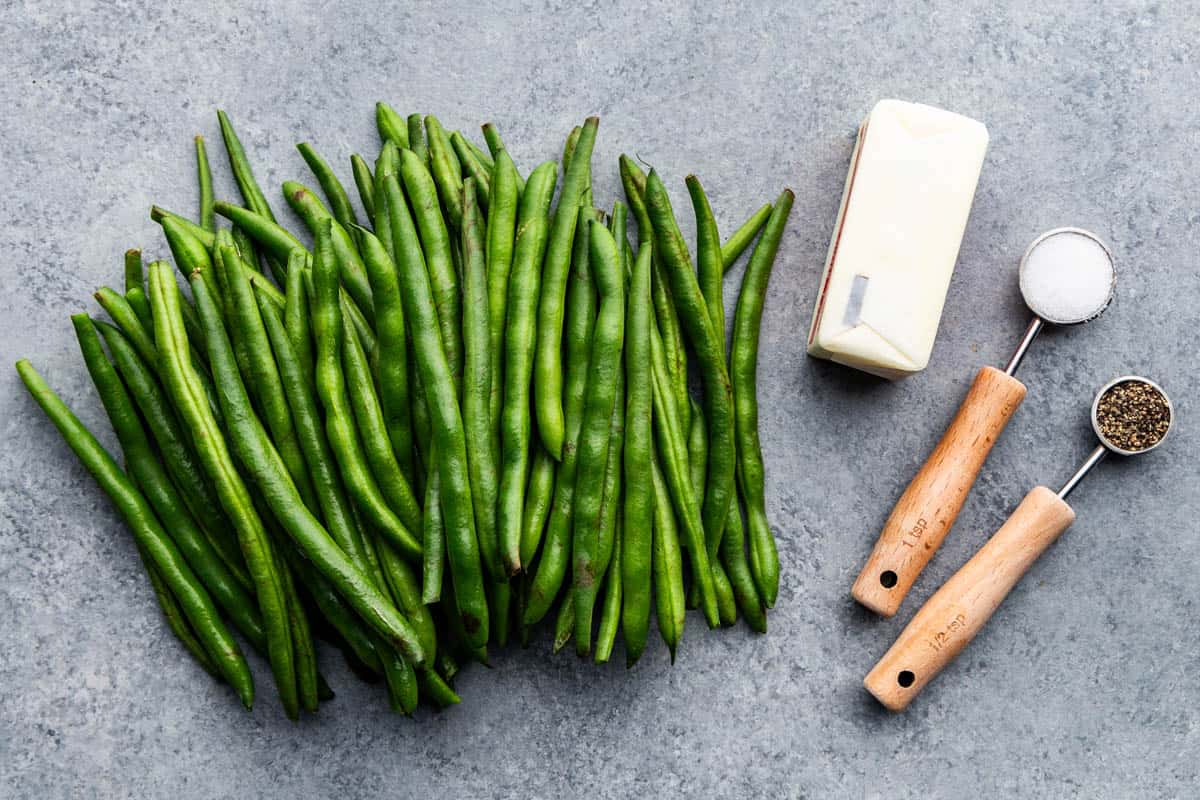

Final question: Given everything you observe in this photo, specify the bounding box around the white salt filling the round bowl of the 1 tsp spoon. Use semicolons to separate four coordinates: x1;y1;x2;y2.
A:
1020;230;1116;324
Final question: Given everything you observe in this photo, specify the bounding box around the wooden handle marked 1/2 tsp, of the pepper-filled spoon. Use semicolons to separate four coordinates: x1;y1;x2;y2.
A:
863;486;1075;711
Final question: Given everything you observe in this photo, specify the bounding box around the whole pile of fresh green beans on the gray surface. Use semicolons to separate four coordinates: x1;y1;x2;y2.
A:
17;103;792;718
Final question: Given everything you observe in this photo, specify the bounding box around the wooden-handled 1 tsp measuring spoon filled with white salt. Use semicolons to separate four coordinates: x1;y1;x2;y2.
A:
850;228;1116;616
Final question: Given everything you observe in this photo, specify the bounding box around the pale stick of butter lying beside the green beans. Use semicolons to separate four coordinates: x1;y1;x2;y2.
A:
809;100;988;379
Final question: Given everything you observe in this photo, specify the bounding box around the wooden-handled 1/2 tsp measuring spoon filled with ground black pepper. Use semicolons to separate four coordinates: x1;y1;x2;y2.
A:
863;375;1175;711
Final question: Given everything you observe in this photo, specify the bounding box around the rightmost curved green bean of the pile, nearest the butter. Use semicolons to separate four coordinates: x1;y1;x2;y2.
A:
730;190;794;608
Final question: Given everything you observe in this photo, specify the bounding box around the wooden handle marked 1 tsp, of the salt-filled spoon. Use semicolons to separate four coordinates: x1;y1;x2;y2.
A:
850;367;1025;616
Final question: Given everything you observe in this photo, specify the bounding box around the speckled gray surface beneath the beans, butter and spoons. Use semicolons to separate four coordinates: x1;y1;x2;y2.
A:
0;0;1200;799
